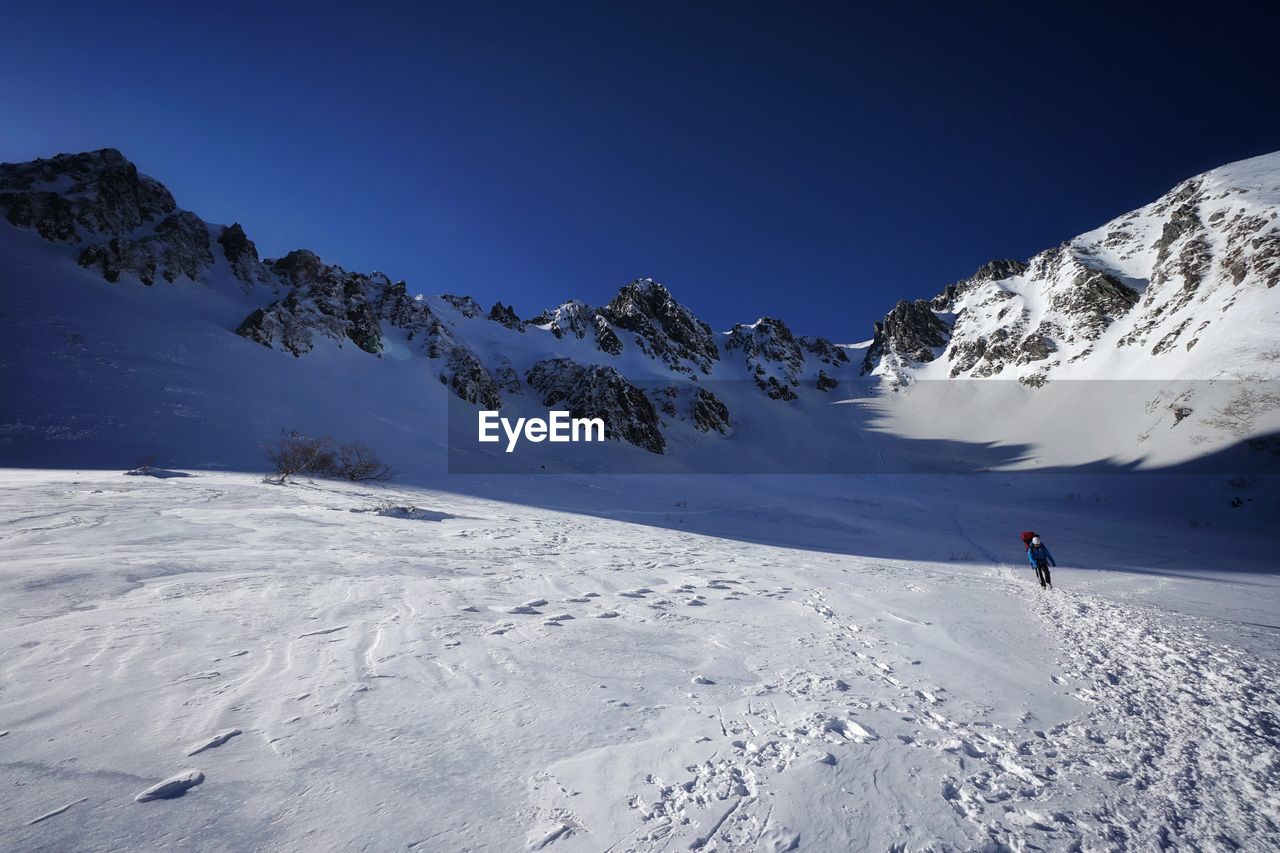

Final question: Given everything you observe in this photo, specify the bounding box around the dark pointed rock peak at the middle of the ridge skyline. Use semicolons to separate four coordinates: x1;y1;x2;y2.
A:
599;278;719;373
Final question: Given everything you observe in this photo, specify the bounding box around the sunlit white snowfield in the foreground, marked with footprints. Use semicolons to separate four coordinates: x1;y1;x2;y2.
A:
0;471;1280;852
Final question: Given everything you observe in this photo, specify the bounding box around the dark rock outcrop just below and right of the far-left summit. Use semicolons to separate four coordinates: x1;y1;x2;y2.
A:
77;210;214;286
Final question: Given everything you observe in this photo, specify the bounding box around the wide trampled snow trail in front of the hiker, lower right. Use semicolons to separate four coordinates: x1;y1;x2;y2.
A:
1036;571;1280;849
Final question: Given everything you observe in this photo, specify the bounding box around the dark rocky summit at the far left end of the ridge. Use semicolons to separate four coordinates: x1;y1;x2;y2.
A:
0;149;178;243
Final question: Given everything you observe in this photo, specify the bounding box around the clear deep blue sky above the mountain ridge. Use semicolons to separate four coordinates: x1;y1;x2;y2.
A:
0;0;1280;341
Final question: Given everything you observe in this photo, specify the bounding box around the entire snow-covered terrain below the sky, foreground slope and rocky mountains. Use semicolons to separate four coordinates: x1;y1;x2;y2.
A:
0;151;1280;853
